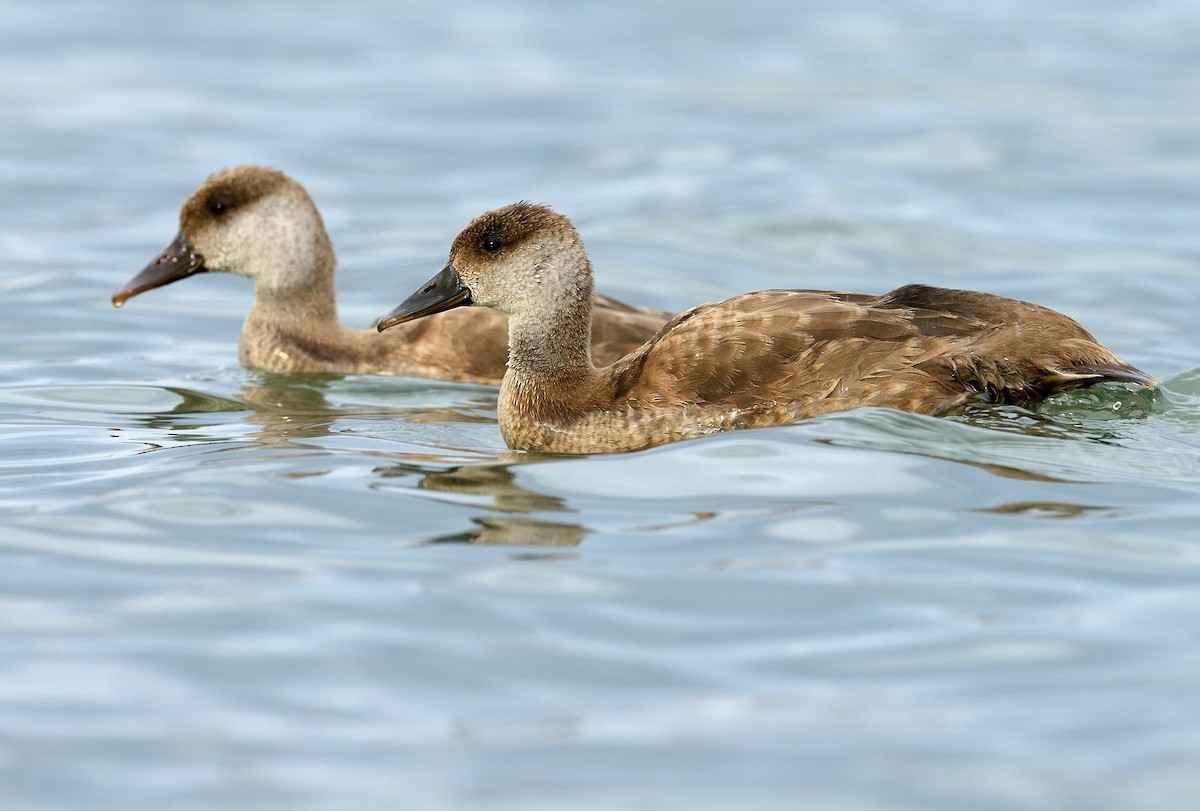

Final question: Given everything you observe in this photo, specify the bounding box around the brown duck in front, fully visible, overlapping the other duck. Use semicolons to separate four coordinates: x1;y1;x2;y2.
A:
377;202;1154;453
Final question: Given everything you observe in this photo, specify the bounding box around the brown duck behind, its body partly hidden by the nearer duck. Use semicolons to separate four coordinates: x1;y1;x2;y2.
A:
113;166;672;385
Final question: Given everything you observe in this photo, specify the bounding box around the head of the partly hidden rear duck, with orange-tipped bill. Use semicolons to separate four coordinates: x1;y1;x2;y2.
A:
113;166;335;307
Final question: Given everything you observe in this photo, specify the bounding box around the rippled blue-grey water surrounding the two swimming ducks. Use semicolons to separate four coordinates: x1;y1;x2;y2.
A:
0;0;1200;811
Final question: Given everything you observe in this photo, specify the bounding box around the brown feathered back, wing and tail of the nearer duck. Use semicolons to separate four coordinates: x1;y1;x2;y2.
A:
610;284;1153;417
